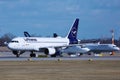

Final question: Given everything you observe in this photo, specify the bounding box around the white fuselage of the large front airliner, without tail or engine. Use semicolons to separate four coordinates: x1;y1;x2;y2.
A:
8;37;69;51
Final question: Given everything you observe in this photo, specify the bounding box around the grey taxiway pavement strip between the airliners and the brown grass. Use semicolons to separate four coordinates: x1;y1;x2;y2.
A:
0;52;120;61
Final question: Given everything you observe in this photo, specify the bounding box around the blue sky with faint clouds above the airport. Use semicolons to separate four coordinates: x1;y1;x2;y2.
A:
0;0;120;39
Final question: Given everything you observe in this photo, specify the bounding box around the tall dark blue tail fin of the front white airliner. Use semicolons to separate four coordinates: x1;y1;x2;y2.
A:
67;18;79;44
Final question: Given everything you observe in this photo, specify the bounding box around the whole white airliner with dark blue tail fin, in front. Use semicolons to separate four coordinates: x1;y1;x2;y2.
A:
8;18;89;57
